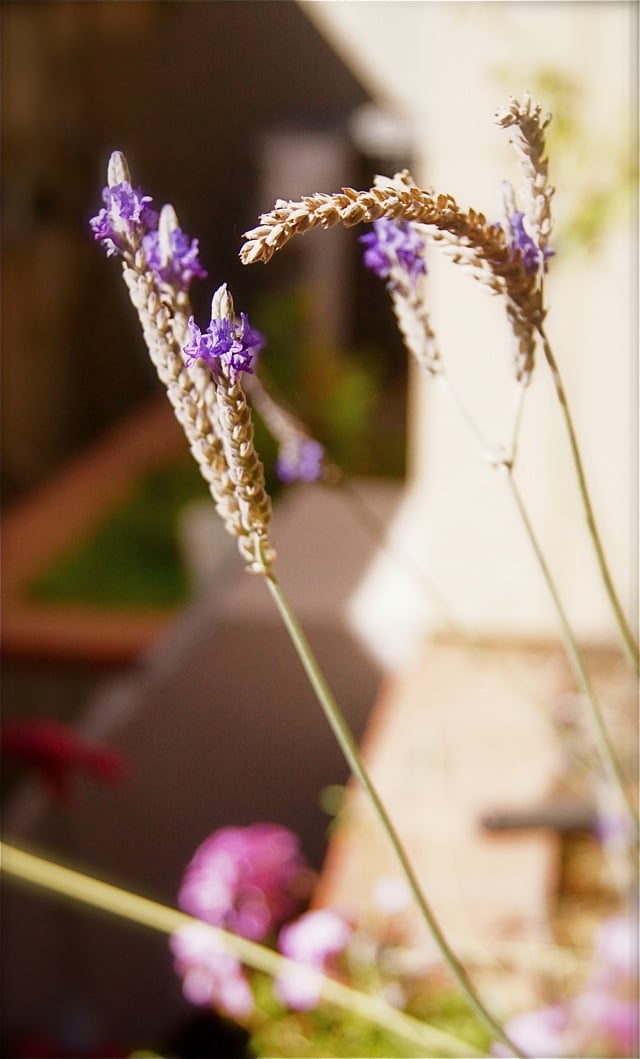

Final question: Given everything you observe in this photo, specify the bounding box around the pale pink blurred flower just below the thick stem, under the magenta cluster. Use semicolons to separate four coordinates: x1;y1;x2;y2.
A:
170;923;253;1019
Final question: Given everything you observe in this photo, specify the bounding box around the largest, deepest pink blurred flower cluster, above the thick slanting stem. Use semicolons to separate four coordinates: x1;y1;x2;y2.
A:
178;824;312;941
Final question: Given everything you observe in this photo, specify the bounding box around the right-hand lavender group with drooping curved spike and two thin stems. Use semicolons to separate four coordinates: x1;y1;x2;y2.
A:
241;94;639;830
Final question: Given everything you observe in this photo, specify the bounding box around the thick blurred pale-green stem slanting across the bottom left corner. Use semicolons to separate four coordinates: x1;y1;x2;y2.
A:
0;842;481;1057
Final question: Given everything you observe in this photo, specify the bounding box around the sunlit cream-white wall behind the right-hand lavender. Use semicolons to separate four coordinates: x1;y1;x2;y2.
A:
301;0;637;652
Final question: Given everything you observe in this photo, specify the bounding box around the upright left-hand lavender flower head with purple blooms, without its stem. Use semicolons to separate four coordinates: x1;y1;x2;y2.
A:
91;152;275;574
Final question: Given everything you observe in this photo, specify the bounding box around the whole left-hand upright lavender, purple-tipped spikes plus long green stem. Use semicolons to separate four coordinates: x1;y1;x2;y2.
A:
91;145;529;1052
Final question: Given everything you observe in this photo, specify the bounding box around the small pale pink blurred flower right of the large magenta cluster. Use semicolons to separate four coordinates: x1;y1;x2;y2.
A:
273;909;352;1011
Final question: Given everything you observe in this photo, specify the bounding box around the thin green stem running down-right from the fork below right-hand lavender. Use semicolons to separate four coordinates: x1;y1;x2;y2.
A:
505;467;640;832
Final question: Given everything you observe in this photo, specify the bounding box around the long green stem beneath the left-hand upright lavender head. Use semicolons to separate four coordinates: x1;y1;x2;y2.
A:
266;573;525;1059
